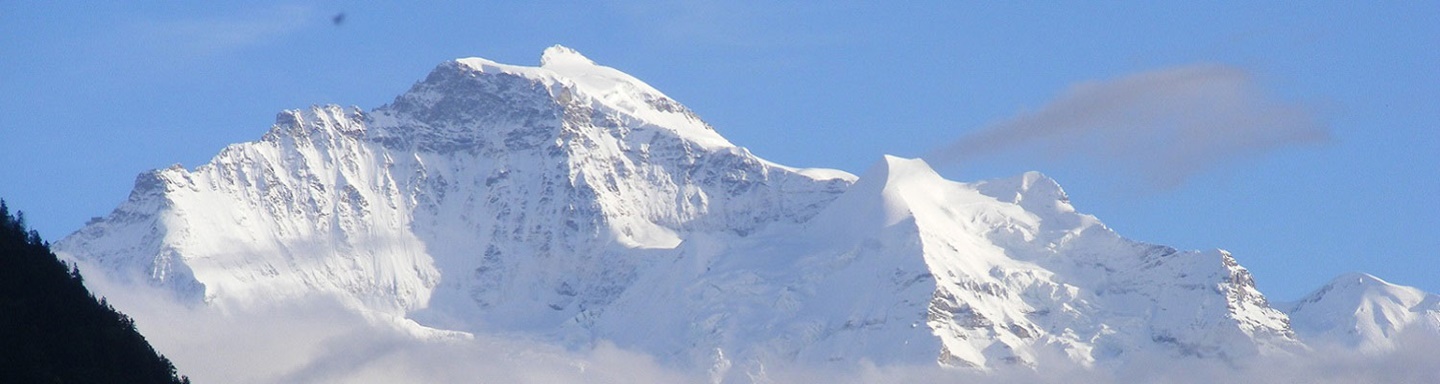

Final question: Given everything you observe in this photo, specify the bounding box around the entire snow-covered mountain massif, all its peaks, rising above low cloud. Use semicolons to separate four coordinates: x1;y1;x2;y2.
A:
56;46;1436;375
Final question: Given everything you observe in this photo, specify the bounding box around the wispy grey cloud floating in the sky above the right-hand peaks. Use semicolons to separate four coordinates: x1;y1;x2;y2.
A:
927;65;1331;188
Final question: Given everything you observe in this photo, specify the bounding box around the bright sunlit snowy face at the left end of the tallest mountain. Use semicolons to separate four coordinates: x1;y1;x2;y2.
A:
56;106;426;313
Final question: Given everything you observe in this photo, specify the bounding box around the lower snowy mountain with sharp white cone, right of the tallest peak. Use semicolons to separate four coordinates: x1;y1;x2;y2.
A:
633;157;1296;368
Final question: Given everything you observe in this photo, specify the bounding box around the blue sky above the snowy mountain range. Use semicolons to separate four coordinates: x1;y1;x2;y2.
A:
0;1;1440;301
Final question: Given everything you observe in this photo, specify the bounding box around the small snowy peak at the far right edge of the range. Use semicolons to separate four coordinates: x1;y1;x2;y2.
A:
1279;273;1440;352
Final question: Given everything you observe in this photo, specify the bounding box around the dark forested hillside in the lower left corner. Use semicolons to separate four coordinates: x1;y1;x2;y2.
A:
0;201;189;383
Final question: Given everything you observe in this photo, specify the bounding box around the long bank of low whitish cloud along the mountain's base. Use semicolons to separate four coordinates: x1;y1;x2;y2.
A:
86;264;1440;384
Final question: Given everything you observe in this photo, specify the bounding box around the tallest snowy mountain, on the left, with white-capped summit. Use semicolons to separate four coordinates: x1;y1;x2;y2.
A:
56;46;854;329
